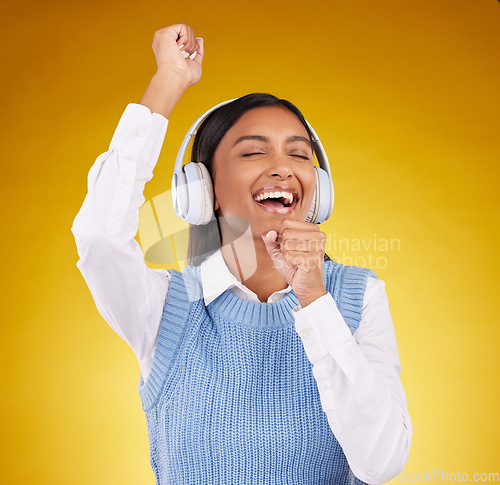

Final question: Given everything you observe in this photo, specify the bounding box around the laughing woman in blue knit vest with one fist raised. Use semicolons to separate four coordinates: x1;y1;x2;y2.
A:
72;20;412;484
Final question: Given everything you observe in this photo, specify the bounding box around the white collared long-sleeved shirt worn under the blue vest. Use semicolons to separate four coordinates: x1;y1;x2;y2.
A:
71;103;413;484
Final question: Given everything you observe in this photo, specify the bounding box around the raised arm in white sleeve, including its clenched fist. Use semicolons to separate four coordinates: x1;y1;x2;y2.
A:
71;24;203;379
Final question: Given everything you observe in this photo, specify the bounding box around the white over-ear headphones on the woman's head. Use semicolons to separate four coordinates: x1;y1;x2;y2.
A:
172;98;334;225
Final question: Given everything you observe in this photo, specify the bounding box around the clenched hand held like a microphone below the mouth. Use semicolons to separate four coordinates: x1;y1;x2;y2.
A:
262;220;327;307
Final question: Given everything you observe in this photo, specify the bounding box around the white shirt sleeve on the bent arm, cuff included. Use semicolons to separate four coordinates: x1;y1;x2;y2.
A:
294;277;413;484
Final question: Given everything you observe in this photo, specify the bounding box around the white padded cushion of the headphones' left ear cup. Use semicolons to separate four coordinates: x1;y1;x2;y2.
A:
183;162;214;225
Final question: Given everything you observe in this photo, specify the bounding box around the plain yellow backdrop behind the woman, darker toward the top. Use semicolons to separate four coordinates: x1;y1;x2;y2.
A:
0;0;500;485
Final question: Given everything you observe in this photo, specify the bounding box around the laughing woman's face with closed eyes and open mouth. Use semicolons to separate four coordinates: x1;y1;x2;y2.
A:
212;106;316;238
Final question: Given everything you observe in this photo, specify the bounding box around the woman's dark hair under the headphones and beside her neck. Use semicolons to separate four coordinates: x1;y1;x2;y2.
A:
186;93;332;266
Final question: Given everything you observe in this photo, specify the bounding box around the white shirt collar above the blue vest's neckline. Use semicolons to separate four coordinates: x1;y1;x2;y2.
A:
200;249;292;305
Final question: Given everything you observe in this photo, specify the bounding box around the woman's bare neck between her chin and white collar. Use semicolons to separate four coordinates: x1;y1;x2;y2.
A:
222;231;288;302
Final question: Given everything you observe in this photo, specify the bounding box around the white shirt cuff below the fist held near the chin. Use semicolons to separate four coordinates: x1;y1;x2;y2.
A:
292;293;354;365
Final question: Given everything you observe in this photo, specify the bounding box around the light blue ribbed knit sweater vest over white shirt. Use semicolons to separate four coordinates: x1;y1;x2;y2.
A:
139;261;375;485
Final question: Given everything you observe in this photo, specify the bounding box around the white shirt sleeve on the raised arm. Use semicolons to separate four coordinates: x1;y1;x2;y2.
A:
71;103;170;380
